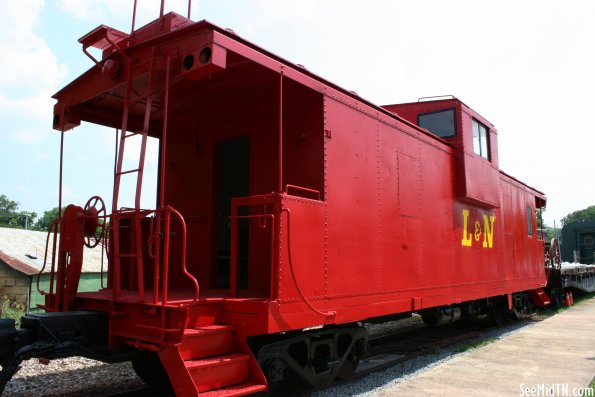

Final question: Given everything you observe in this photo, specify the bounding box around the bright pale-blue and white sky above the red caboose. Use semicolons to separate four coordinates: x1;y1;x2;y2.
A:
0;0;595;225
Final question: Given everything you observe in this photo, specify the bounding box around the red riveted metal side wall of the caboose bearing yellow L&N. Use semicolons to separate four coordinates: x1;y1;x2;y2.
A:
272;96;545;326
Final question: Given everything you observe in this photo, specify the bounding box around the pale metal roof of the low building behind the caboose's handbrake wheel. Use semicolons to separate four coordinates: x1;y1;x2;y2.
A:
0;228;107;276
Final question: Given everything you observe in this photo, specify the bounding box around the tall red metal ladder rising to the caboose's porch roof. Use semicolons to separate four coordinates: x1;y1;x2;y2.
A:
110;55;163;302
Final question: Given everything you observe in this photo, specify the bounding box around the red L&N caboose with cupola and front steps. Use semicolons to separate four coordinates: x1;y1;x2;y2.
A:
3;9;547;396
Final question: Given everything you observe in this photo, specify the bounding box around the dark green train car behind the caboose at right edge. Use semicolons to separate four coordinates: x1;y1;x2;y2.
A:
560;221;595;265
